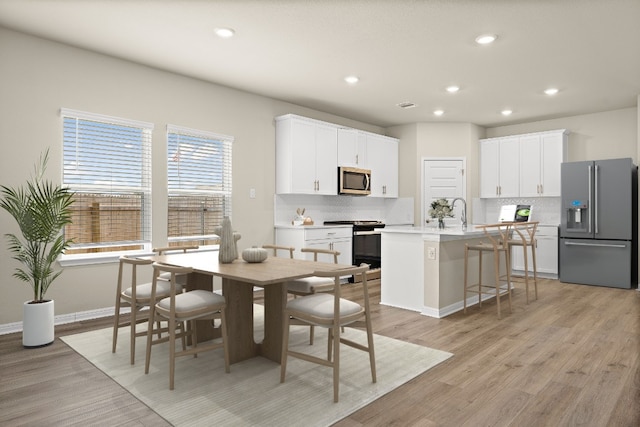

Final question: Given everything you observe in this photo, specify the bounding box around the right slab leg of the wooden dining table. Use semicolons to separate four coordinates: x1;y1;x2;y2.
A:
259;283;287;363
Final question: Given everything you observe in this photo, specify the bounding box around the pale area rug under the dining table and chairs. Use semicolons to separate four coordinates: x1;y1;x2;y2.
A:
61;306;452;426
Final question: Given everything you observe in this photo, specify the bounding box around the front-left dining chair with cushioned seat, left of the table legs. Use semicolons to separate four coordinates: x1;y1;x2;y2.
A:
144;262;230;390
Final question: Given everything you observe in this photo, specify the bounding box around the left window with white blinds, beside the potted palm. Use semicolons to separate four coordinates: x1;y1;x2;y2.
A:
61;109;153;255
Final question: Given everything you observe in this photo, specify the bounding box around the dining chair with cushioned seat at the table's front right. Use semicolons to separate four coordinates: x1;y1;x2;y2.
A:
280;264;376;402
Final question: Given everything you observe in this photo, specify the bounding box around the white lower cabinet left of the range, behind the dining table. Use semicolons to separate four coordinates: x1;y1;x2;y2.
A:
276;226;353;265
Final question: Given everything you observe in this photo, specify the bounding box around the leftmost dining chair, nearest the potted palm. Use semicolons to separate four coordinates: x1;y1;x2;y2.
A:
111;256;182;365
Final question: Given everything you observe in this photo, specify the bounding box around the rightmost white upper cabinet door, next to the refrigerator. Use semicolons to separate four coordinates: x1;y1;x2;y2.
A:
540;132;567;197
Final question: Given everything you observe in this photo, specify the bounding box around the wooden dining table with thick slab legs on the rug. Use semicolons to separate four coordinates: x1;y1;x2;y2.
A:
151;251;350;363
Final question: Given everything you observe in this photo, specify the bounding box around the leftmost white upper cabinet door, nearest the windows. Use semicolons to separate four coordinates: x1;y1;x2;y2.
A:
290;119;317;194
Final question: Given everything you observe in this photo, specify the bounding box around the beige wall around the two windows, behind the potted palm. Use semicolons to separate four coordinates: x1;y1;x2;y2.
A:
0;28;384;325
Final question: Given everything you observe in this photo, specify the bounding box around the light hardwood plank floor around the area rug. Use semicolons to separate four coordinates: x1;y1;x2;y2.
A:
0;280;640;427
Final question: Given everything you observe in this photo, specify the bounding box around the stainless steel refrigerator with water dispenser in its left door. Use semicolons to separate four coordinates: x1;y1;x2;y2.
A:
558;158;638;288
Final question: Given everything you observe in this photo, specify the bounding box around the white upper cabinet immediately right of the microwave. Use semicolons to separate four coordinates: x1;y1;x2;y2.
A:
366;133;398;198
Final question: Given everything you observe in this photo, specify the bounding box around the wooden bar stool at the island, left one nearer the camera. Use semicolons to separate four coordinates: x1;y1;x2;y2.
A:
463;223;513;319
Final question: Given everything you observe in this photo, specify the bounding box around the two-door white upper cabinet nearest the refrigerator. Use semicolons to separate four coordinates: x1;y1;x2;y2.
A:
520;130;567;197
